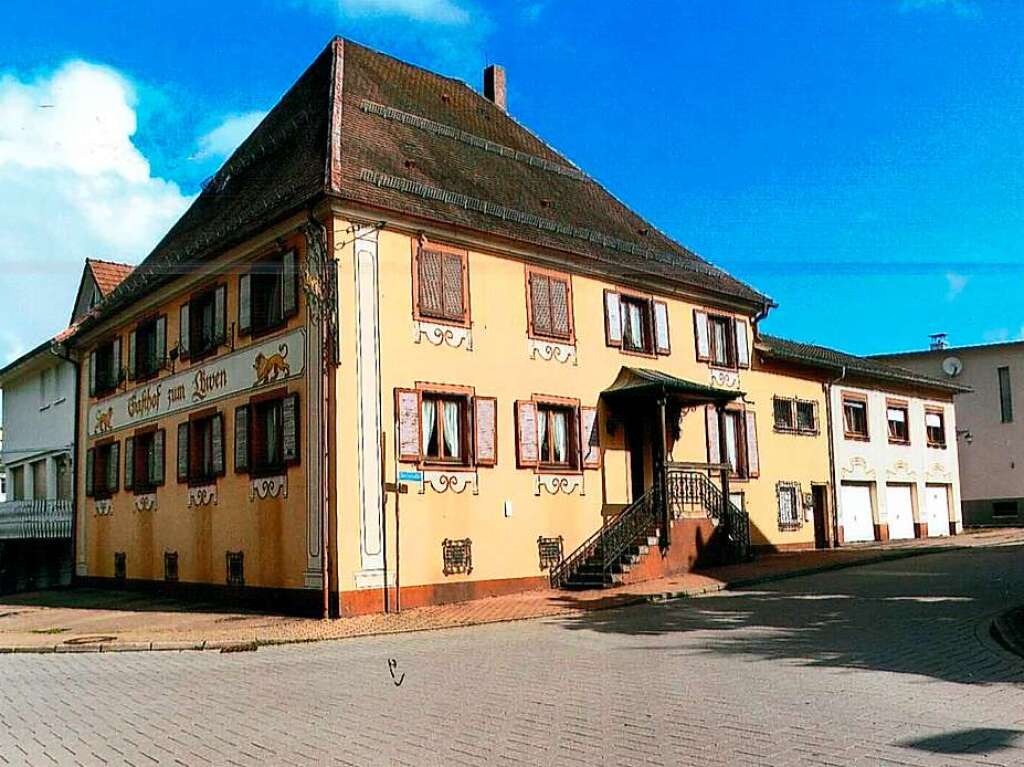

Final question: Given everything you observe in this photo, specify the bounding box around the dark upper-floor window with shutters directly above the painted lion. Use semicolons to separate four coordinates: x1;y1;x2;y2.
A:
239;251;299;336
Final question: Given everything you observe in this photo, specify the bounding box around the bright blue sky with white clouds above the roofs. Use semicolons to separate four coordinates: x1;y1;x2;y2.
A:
0;0;1024;364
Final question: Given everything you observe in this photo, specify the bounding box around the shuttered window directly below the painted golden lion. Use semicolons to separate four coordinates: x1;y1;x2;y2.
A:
234;392;299;476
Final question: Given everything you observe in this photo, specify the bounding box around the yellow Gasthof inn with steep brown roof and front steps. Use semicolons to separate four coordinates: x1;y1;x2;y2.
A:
68;40;946;614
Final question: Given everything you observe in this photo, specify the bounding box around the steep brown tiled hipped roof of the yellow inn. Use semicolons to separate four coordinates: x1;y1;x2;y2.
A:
77;38;771;333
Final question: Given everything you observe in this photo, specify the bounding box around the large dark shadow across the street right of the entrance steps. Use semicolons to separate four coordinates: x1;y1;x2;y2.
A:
558;546;1024;684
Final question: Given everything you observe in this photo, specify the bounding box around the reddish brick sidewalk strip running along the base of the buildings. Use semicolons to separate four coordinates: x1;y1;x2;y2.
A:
0;528;1024;651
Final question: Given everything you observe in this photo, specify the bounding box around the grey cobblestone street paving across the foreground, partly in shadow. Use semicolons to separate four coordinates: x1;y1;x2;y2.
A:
0;546;1024;766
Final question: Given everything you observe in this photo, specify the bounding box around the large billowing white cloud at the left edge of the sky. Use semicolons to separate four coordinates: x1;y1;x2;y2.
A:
0;61;190;365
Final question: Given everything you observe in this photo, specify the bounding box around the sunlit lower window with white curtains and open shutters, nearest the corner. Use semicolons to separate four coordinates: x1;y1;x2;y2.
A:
395;384;498;466
